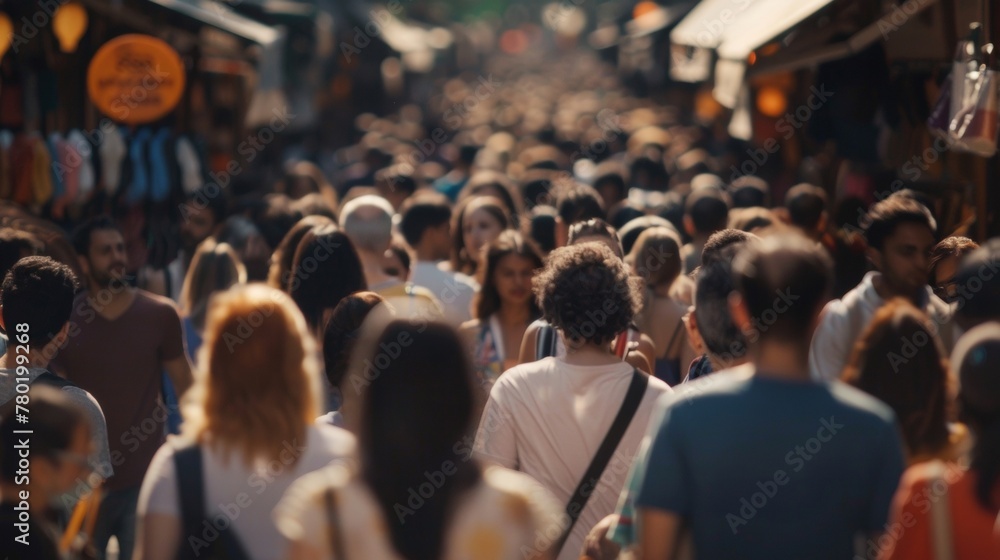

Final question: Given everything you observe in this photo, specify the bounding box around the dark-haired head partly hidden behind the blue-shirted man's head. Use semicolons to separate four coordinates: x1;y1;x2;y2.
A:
694;247;747;365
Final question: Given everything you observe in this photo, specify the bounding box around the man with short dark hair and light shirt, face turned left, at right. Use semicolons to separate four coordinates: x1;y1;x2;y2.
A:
809;195;955;380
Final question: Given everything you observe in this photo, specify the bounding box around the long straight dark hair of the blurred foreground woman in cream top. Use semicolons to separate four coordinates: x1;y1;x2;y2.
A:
356;318;480;558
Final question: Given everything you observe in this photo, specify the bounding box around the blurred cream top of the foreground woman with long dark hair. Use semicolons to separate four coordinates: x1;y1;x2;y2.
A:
274;466;564;560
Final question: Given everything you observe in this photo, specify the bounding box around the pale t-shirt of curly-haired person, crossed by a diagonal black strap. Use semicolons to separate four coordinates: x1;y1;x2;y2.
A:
475;357;671;560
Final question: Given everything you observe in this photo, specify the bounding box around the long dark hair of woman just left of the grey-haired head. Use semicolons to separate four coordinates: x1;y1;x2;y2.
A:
288;225;368;332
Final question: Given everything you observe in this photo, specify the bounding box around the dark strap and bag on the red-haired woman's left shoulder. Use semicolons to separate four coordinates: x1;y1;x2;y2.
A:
174;445;250;560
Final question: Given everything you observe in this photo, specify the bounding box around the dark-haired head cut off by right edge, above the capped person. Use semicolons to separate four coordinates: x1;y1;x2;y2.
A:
955;237;1000;330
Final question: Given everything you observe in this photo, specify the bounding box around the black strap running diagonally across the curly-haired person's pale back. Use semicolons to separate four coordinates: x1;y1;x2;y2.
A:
552;368;649;557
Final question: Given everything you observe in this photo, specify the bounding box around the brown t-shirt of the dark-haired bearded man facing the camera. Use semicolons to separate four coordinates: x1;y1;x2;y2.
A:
55;290;184;490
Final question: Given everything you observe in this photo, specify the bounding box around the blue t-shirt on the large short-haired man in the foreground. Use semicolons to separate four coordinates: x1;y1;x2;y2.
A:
636;376;903;560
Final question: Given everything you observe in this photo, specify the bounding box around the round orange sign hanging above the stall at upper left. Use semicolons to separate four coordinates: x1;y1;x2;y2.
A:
87;34;184;124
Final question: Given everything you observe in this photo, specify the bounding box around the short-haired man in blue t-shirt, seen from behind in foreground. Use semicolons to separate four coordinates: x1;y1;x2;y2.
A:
636;236;903;560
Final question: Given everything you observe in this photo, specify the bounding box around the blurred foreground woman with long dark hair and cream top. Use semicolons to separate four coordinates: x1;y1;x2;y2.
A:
274;309;563;560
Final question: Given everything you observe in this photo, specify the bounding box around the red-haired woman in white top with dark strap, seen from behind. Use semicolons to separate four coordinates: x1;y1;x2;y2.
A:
136;284;354;560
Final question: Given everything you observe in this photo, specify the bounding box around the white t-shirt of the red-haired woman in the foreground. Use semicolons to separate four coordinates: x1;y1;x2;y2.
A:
138;425;355;560
